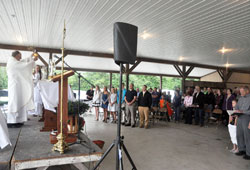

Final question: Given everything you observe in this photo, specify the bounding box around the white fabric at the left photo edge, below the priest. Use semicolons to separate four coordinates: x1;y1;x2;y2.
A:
0;109;11;149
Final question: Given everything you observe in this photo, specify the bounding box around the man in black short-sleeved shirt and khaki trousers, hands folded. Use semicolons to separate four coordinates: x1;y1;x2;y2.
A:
124;83;137;128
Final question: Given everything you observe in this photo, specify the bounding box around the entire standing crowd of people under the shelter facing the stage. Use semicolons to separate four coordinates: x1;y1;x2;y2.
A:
87;83;250;159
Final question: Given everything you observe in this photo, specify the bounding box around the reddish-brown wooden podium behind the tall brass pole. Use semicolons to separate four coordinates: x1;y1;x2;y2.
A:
50;70;77;144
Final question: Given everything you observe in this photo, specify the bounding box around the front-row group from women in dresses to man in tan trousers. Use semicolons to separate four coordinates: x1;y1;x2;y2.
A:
86;84;154;128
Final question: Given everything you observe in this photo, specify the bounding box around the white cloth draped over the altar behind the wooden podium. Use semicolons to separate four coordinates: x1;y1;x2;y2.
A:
37;80;75;112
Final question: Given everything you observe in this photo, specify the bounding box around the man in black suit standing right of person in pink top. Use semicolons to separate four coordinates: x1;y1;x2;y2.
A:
193;86;205;126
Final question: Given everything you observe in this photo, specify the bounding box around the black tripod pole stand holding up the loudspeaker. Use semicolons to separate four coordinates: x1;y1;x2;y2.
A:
93;63;137;170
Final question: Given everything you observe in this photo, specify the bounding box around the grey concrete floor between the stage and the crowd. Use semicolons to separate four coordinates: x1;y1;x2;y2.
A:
49;111;250;170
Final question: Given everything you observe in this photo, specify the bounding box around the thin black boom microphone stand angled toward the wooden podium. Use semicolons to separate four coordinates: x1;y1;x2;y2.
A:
54;55;95;152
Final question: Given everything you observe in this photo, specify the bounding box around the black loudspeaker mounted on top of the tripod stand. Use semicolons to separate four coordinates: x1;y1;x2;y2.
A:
114;22;138;65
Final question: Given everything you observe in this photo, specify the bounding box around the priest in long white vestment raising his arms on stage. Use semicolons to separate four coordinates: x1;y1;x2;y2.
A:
7;51;38;127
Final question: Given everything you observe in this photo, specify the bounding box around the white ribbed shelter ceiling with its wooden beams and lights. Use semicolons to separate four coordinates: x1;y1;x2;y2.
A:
0;0;250;91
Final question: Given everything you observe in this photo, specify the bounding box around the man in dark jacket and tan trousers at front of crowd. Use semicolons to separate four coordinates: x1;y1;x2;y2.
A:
138;85;152;129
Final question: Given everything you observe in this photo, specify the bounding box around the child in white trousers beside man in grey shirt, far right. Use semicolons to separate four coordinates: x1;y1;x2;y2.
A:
228;100;238;153
